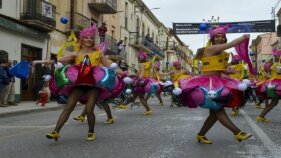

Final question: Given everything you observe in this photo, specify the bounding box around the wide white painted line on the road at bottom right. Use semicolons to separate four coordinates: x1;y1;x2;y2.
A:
240;110;281;158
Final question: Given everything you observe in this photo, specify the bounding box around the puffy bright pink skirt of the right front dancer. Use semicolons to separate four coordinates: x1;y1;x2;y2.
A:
179;75;246;109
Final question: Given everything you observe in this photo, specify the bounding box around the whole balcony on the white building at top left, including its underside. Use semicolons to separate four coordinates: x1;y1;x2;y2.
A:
20;0;56;32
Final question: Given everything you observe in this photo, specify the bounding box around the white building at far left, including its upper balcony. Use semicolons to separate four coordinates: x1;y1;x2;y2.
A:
0;0;56;101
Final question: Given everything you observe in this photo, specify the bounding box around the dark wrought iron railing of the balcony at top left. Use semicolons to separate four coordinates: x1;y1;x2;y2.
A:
20;0;56;27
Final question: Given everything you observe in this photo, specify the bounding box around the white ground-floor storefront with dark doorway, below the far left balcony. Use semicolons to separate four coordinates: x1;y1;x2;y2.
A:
0;15;49;101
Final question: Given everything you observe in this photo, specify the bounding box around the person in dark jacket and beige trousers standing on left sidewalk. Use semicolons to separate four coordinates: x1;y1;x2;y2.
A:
3;60;17;106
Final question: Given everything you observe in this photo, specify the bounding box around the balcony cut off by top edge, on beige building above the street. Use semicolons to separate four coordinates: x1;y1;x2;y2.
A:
88;0;117;14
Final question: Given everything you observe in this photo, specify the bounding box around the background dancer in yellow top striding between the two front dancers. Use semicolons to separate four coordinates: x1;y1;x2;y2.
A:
118;50;160;115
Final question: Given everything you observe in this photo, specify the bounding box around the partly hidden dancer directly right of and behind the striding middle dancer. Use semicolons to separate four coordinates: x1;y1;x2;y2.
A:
145;62;163;106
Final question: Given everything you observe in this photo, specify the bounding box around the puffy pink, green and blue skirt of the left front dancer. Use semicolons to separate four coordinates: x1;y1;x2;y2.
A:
50;65;125;102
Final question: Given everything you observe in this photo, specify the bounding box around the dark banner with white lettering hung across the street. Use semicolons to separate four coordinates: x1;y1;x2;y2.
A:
173;20;275;35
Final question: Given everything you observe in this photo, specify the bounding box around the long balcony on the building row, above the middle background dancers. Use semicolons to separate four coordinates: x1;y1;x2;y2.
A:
130;36;165;59
